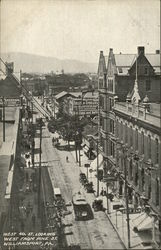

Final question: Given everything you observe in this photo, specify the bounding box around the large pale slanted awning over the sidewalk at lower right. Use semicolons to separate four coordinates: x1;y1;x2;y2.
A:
133;213;153;232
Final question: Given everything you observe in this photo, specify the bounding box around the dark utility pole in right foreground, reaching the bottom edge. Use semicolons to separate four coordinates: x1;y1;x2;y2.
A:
123;149;130;249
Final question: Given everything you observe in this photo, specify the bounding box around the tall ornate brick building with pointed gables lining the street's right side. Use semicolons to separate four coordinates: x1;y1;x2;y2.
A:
98;47;161;241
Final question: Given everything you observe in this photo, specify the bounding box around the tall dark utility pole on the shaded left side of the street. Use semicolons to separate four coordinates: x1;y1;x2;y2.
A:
38;118;42;217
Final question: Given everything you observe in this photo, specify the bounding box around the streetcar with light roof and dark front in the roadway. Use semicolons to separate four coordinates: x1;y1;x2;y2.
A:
72;192;91;220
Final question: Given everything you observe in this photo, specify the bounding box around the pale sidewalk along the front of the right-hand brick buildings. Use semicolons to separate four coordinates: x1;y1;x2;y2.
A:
71;147;144;249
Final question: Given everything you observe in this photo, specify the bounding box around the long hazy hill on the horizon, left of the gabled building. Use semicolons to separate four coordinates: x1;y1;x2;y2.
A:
1;52;97;73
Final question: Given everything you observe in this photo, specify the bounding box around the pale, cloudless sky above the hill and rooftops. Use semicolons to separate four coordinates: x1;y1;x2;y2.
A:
0;0;160;63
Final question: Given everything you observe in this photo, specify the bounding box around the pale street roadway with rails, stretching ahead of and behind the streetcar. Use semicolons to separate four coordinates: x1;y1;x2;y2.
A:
39;122;124;249
